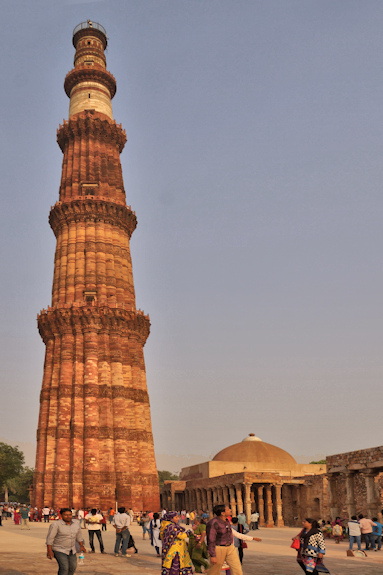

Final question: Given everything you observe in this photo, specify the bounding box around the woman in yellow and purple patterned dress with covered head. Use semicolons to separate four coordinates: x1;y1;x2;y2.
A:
160;511;193;575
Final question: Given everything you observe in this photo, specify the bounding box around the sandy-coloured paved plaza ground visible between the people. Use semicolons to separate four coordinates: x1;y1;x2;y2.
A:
0;520;383;575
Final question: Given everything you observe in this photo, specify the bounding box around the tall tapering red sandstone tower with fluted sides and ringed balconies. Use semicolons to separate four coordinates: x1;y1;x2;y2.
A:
32;21;159;511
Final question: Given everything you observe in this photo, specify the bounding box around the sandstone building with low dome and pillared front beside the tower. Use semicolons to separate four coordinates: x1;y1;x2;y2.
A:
161;433;327;527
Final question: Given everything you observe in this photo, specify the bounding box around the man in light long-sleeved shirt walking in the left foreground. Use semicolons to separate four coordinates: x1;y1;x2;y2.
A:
46;507;86;575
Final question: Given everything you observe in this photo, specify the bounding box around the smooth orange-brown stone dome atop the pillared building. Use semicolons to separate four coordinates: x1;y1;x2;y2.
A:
213;433;297;469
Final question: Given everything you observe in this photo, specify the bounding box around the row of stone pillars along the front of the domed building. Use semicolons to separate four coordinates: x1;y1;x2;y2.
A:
161;483;284;527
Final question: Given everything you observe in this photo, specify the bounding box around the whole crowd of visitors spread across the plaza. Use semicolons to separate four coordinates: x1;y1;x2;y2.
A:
4;504;383;575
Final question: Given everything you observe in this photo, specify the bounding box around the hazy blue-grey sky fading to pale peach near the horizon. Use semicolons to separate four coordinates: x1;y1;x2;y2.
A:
0;0;383;472
